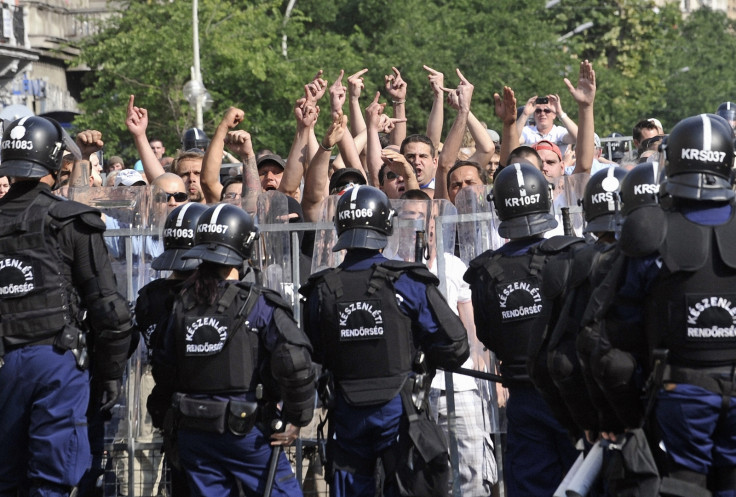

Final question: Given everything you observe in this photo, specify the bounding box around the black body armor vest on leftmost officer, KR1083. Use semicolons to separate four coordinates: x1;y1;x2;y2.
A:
0;192;79;346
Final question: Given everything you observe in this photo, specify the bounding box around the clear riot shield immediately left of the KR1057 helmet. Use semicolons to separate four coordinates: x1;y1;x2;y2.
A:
455;185;506;265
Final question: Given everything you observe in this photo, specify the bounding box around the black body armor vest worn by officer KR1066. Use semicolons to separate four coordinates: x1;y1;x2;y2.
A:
316;264;415;405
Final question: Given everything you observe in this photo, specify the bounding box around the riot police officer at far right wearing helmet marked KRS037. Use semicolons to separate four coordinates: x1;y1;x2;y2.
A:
600;114;736;497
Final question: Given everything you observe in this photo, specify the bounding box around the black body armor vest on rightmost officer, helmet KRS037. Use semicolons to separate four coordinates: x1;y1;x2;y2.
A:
645;210;736;368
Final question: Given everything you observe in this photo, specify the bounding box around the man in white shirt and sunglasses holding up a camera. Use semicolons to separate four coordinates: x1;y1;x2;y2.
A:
516;95;578;153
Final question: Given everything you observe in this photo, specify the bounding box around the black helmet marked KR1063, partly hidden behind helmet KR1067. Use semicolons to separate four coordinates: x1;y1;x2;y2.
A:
151;202;207;271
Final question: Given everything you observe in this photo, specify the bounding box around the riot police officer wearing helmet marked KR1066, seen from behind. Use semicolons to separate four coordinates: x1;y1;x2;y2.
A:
300;185;469;497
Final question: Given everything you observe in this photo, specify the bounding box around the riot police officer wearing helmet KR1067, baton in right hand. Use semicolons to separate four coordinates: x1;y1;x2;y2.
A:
156;204;314;496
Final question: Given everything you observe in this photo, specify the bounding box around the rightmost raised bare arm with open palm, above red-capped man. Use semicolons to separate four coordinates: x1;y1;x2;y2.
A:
565;60;596;173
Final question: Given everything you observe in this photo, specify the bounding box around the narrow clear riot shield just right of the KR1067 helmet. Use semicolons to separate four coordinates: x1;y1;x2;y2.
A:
251;190;295;306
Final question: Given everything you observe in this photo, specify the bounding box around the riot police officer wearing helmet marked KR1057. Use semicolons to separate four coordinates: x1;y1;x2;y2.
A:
465;164;583;497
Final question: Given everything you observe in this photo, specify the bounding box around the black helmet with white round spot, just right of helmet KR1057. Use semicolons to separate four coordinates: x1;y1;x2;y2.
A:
583;166;626;233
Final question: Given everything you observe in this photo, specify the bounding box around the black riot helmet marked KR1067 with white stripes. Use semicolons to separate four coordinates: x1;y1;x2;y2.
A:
184;204;258;266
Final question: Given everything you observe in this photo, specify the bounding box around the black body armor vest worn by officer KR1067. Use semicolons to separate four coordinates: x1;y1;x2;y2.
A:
172;282;266;394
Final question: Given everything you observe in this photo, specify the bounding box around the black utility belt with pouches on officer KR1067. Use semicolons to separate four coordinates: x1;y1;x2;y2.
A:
172;393;268;436
